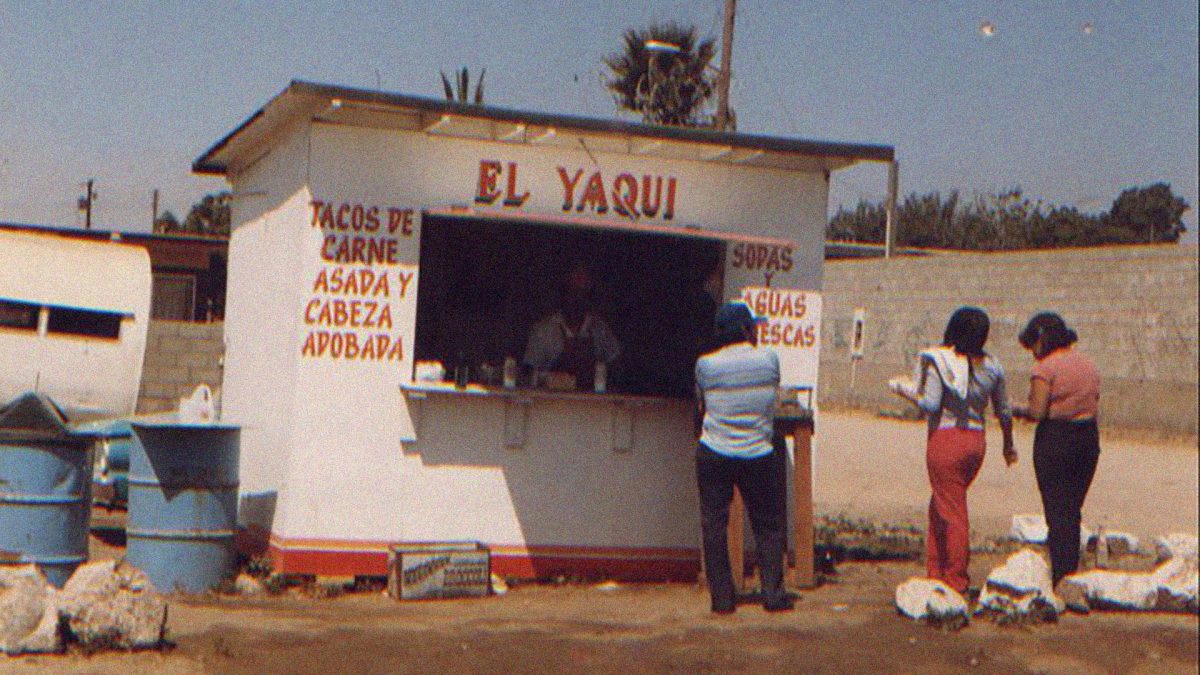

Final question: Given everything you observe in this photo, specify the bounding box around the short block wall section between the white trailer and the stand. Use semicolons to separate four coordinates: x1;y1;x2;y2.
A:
138;321;224;414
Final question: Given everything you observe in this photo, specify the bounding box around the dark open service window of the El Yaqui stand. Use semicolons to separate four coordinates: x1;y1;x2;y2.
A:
415;213;726;398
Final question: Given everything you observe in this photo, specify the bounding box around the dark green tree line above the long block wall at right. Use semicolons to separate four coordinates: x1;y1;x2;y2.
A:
826;183;1189;251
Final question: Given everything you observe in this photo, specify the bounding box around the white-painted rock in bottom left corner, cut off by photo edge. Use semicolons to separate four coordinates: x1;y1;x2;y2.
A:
0;565;62;655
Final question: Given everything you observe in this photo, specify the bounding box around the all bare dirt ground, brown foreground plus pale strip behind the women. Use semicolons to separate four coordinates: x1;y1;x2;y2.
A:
0;414;1200;674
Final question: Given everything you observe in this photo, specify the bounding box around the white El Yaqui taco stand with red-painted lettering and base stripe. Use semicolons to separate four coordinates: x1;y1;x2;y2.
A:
193;82;893;579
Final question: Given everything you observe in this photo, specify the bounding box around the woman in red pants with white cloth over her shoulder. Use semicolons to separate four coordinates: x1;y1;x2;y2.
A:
888;307;1016;595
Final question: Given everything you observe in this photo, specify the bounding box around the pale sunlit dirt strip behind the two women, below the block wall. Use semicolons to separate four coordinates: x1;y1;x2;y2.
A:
812;412;1200;543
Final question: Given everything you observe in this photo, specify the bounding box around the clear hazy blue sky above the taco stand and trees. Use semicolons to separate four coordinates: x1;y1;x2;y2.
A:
0;0;1200;241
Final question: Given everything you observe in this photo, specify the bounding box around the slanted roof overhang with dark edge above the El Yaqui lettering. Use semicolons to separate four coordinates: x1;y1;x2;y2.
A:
192;80;895;175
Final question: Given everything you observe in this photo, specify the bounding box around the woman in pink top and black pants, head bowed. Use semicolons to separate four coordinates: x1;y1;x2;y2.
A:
1014;312;1100;585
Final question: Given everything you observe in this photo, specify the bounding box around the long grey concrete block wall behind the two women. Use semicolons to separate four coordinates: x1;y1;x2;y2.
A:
821;245;1200;436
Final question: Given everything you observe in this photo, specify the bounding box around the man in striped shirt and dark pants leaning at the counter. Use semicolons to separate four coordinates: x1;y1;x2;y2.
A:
696;303;792;614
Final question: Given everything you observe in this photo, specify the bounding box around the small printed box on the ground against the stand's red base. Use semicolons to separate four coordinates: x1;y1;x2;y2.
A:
388;542;492;601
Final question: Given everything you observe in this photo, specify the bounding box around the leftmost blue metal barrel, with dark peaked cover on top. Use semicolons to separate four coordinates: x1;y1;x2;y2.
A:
0;393;94;587
